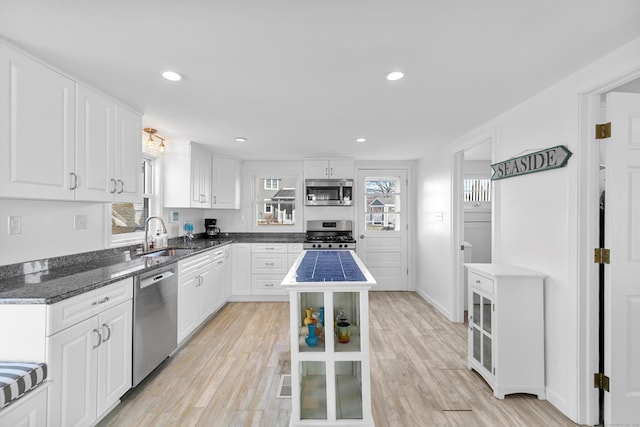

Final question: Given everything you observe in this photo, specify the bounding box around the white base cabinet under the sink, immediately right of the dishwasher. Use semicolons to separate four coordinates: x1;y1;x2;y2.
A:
178;251;213;343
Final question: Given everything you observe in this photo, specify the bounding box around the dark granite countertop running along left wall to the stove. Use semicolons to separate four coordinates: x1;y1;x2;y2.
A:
0;233;304;304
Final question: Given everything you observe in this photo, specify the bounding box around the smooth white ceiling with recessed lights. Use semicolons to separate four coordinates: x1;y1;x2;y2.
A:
0;0;640;160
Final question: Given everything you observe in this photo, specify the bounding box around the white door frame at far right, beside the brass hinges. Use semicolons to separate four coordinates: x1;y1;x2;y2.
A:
576;64;640;425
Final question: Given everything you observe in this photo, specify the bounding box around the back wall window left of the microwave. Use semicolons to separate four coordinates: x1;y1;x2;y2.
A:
253;177;298;228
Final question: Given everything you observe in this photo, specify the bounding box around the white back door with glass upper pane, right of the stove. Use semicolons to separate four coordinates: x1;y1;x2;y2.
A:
356;169;408;291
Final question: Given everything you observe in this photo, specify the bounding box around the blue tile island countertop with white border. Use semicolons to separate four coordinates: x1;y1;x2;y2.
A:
281;250;376;289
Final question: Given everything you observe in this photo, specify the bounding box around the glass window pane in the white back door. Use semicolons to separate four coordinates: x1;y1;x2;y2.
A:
364;176;401;231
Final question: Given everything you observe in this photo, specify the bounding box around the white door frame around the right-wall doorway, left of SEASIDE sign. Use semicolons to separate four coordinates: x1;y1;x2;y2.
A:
451;131;497;323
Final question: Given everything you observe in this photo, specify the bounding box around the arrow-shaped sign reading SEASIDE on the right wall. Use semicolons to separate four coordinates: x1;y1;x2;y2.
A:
491;145;572;181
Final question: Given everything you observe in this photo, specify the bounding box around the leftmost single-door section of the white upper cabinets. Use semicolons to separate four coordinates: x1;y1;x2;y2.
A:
0;44;75;200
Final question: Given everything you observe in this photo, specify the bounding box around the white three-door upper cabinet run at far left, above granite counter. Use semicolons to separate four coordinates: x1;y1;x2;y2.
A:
0;44;142;202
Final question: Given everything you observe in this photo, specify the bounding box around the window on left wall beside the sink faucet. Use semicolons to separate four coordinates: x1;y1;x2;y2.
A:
111;159;153;242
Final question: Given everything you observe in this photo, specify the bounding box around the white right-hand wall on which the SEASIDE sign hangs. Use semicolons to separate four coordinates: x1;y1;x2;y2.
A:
417;39;640;421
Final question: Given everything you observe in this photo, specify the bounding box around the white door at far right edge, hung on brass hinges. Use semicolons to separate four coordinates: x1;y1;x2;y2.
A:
604;93;640;425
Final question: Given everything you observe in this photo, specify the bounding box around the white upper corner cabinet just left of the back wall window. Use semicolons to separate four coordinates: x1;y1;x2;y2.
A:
211;156;240;209
